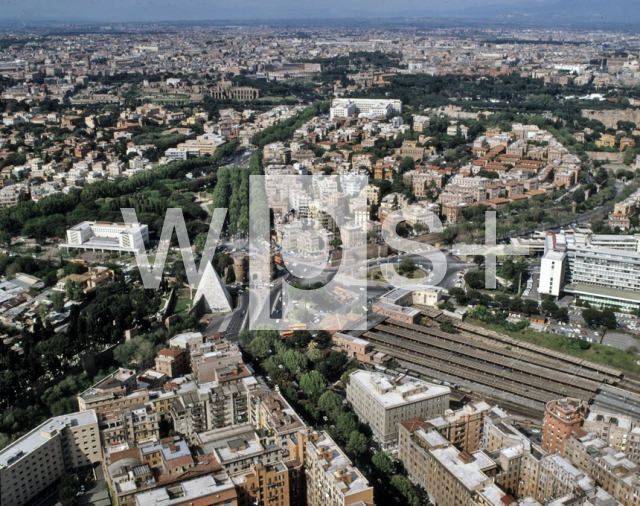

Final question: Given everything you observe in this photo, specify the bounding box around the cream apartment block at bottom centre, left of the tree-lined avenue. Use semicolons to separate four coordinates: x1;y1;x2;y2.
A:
289;428;373;506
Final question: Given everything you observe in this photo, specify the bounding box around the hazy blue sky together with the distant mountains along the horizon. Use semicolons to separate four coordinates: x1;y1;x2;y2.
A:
0;0;640;25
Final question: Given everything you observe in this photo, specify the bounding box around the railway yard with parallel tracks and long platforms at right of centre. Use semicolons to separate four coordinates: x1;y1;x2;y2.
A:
347;305;640;421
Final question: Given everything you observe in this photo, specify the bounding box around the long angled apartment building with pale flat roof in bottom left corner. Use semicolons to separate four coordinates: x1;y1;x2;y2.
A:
0;411;102;506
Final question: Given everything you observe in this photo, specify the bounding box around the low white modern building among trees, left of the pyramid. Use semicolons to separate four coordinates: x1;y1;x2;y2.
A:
60;221;149;253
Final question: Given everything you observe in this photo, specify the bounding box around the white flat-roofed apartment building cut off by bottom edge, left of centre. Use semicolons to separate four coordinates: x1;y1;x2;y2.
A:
134;474;242;506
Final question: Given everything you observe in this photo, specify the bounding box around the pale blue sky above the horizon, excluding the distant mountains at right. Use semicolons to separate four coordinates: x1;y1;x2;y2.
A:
0;0;540;21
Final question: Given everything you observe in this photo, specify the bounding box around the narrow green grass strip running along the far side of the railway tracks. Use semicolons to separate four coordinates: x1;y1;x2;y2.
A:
465;318;640;374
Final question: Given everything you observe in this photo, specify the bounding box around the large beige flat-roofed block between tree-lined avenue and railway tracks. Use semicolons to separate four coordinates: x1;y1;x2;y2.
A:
347;370;451;449
